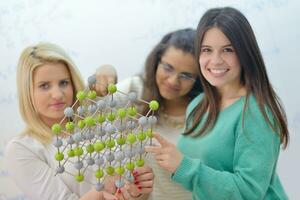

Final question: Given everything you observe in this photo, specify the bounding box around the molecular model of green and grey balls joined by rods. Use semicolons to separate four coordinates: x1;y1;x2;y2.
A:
52;76;159;191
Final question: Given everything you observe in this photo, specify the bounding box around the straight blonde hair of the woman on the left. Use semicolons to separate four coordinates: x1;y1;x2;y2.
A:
17;43;84;144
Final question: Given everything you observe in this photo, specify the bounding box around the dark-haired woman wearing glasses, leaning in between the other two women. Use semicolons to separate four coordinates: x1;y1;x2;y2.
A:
96;29;202;200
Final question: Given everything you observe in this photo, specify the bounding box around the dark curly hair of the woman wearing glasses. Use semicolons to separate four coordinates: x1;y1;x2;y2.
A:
142;28;203;114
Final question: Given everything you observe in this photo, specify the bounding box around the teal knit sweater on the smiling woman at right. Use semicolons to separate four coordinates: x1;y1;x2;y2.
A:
172;94;287;200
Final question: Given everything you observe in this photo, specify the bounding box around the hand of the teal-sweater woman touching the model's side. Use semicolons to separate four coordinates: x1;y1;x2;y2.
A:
145;133;183;173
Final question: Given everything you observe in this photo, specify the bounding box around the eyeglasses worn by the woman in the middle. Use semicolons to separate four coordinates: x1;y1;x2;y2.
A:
158;61;196;82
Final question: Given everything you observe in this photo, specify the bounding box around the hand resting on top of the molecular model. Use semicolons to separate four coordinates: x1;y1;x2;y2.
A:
95;64;118;96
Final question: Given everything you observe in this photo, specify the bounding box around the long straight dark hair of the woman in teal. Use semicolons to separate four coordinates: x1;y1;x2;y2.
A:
184;7;289;147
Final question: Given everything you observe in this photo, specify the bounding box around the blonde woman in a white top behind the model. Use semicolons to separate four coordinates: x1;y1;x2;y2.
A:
5;43;151;200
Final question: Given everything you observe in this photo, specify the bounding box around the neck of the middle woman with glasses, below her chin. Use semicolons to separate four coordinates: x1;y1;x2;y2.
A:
163;97;189;116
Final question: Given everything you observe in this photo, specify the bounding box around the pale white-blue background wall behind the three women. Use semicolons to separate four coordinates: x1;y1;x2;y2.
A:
0;0;300;200
